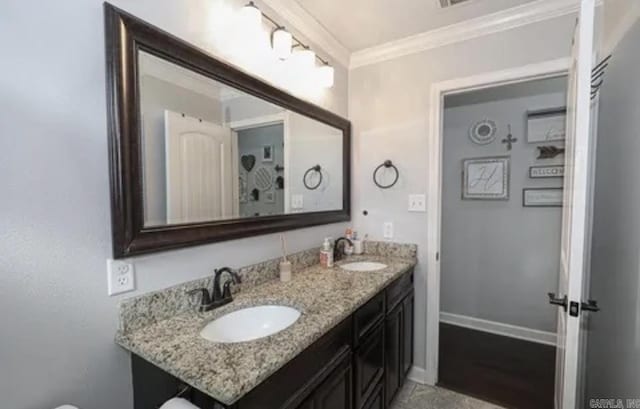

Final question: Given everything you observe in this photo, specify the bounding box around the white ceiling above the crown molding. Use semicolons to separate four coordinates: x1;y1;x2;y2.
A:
295;0;533;52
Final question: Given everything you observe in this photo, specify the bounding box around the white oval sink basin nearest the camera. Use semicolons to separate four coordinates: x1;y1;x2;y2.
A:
200;305;300;343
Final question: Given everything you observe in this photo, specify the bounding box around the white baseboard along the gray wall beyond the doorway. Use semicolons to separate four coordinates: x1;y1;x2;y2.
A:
440;312;556;346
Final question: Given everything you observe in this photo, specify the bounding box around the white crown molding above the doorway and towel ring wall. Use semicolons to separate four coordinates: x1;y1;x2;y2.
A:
349;0;580;69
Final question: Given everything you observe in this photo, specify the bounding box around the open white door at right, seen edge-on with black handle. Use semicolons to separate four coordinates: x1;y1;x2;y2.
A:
555;0;595;409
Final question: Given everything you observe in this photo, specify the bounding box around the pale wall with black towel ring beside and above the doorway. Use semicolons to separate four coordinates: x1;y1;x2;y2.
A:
349;16;575;368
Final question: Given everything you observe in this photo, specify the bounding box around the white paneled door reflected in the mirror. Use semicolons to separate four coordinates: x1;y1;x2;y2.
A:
165;111;234;224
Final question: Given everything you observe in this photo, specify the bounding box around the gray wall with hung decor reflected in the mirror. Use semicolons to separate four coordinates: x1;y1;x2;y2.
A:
238;124;284;217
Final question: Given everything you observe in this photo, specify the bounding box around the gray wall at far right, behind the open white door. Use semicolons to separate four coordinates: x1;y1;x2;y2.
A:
586;18;640;399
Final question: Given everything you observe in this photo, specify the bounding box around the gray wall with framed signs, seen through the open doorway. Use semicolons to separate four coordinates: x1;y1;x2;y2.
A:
440;77;566;332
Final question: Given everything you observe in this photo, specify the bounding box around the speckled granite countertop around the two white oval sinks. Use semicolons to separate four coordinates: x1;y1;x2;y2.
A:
116;255;416;405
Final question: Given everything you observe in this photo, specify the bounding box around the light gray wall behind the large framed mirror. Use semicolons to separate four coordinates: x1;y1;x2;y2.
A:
0;0;347;409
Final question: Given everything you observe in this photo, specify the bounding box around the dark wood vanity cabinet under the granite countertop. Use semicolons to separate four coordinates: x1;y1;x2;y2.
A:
132;271;414;409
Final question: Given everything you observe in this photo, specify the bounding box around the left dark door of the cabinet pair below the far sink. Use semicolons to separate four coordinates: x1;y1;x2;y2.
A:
384;303;403;406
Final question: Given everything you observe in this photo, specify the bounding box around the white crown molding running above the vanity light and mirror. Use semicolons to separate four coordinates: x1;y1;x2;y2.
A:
260;0;351;68
